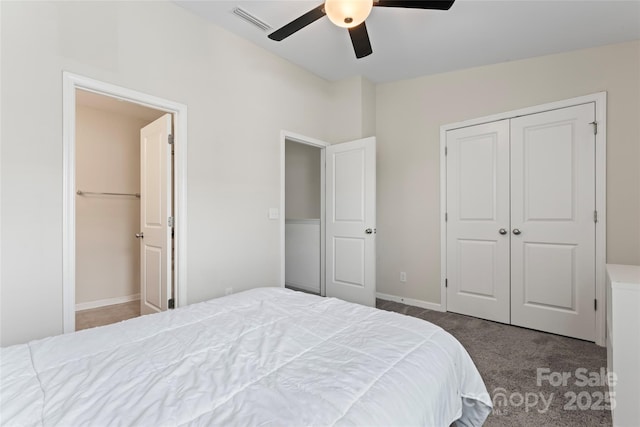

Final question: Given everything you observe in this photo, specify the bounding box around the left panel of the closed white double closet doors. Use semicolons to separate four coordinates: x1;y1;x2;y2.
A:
446;120;510;323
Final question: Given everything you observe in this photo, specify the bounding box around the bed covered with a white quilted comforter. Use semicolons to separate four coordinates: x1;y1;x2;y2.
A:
0;288;491;426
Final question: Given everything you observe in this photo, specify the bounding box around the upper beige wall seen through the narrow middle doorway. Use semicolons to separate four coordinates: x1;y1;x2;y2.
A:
284;141;321;219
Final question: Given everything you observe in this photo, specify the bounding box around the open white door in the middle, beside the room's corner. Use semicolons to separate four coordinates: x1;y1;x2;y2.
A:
325;137;376;307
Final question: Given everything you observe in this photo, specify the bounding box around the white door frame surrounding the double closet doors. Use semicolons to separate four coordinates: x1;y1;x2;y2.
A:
440;92;607;346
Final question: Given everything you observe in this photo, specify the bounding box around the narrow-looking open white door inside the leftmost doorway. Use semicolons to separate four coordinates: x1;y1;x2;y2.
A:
140;114;172;314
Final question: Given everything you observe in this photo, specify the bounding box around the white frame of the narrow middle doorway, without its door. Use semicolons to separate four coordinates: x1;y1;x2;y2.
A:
279;130;331;296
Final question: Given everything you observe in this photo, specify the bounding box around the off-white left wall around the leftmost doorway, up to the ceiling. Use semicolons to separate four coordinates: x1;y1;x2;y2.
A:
0;2;340;346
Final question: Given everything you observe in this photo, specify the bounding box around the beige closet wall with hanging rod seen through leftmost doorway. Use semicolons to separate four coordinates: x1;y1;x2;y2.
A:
76;105;148;304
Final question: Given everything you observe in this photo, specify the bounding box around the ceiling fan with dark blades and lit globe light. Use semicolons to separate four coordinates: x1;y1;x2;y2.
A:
268;0;455;58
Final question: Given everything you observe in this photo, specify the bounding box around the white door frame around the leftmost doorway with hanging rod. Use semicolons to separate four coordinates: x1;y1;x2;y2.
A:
62;71;187;333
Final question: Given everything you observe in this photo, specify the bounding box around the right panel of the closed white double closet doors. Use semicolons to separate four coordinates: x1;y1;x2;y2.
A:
511;103;595;341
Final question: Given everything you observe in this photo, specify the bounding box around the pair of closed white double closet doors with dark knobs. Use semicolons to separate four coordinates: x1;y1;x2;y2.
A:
446;103;595;341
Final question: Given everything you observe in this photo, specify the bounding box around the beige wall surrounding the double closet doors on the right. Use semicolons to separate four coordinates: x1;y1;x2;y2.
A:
376;41;640;303
